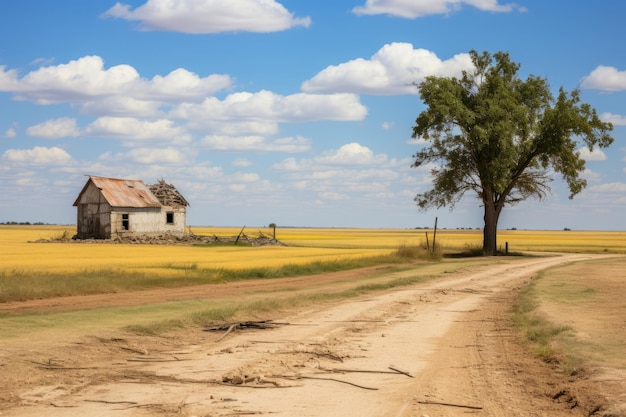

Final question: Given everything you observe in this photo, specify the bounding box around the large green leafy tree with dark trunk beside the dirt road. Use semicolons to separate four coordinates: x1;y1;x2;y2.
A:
412;51;613;254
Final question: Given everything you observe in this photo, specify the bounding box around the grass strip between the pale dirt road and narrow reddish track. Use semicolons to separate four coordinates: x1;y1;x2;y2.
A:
0;262;444;340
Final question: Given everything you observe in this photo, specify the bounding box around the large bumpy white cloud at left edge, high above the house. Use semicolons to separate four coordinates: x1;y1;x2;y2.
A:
0;56;231;110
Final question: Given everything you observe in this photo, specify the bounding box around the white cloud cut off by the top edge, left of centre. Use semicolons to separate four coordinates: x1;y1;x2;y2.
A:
103;0;311;34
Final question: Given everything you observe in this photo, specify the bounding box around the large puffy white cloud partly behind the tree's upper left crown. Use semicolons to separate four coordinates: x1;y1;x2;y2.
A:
302;42;473;95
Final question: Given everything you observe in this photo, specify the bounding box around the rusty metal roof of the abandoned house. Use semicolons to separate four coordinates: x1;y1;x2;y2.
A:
74;176;161;207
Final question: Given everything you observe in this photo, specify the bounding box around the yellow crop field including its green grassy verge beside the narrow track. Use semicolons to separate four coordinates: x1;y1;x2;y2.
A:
0;225;626;302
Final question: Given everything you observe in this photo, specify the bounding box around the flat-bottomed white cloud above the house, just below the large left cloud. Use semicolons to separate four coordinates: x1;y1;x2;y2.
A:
83;117;191;144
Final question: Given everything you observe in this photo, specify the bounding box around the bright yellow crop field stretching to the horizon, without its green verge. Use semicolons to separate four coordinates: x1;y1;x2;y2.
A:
0;225;626;274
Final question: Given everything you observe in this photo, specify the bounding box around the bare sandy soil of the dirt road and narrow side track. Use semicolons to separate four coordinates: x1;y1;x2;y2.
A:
0;255;623;417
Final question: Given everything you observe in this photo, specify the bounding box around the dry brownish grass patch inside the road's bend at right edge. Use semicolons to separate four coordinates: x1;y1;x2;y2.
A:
513;256;626;375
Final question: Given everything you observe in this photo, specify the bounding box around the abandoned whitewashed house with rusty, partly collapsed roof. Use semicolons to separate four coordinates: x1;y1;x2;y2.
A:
74;176;189;239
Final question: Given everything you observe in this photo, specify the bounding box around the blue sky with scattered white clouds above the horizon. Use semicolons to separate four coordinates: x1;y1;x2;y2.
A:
0;0;626;230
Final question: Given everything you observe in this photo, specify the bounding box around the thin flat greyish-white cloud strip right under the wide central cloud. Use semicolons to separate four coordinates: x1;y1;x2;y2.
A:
200;135;311;153
